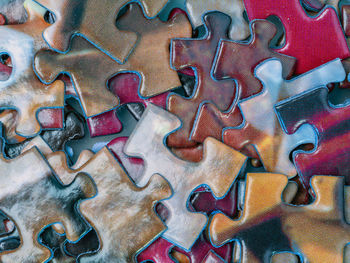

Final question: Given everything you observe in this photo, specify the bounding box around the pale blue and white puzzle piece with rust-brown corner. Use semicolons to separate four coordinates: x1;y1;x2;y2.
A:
223;59;345;177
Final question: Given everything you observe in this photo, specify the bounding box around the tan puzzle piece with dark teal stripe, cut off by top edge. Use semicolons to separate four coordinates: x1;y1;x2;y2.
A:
38;0;171;63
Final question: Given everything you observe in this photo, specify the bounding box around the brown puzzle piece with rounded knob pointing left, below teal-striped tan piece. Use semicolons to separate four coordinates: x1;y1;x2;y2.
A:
34;36;118;117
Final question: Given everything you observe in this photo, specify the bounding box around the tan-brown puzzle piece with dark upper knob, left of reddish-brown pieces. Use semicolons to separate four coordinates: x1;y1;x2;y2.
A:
117;3;192;97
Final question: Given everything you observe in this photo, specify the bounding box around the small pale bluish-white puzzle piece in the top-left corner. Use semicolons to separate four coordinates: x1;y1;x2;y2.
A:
0;0;27;24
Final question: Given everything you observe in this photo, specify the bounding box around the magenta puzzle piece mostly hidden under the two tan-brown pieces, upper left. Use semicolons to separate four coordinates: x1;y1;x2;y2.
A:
87;73;168;137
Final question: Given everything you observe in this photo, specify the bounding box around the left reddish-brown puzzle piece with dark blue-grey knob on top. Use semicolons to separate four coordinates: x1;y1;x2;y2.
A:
167;12;236;148
